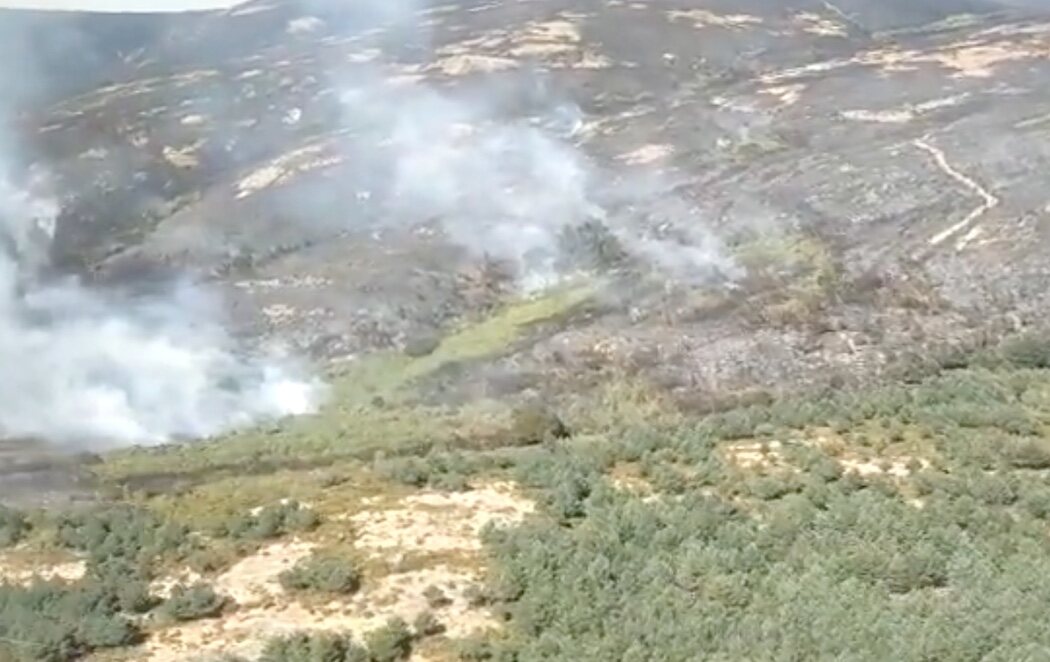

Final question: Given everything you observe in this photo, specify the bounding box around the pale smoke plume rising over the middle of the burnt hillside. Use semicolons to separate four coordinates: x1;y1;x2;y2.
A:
318;0;738;289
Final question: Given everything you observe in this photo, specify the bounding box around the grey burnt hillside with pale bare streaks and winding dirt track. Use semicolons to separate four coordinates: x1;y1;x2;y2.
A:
19;0;1050;418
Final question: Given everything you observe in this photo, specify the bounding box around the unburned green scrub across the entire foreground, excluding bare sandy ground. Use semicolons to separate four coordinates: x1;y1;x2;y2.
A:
6;335;1050;662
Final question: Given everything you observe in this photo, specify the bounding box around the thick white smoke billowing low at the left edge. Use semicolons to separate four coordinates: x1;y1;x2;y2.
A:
0;168;318;448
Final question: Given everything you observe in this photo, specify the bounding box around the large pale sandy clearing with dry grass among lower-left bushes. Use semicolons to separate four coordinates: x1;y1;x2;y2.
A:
129;480;534;662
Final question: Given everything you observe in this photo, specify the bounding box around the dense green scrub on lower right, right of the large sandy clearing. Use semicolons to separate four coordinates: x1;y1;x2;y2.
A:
461;350;1050;661
